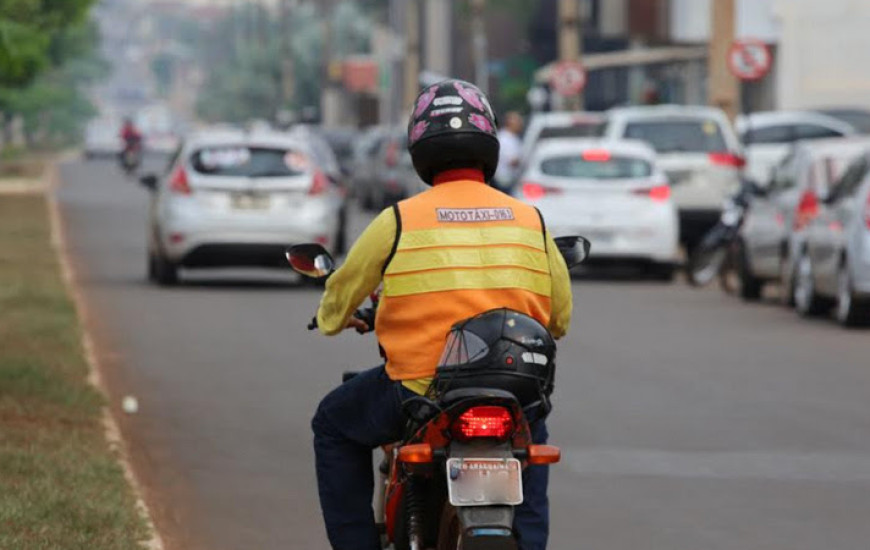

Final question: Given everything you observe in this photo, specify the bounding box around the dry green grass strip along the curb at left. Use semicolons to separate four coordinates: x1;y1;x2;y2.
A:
0;195;148;550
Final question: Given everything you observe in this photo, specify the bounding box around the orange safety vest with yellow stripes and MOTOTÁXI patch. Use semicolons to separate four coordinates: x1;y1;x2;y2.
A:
375;180;552;380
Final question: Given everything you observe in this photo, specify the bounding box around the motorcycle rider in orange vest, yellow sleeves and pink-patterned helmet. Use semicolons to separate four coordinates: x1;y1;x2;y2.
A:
312;80;572;550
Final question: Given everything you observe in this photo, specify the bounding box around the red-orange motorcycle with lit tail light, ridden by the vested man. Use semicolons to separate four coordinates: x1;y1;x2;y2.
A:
287;237;590;550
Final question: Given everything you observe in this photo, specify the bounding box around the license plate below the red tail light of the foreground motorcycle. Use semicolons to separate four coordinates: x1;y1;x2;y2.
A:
447;458;523;506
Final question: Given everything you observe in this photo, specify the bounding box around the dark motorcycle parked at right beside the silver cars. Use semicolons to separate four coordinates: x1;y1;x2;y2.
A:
688;180;757;292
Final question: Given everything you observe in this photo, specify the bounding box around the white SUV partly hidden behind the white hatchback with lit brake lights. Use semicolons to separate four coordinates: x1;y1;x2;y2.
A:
602;105;743;248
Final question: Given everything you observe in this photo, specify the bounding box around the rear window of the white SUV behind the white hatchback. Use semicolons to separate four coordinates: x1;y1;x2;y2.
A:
625;119;728;153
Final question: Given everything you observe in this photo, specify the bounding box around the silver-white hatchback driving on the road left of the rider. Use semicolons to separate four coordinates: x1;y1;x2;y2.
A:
142;131;344;285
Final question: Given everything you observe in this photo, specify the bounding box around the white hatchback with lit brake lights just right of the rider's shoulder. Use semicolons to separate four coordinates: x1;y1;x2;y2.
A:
515;138;679;280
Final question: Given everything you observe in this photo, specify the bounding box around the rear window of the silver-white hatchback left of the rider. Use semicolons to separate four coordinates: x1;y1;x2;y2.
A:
190;146;310;178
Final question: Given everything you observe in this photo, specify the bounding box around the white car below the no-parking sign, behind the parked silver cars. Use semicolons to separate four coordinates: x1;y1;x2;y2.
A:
735;111;856;187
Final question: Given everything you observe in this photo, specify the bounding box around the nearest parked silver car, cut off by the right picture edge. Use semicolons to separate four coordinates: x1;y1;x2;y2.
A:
794;152;870;326
